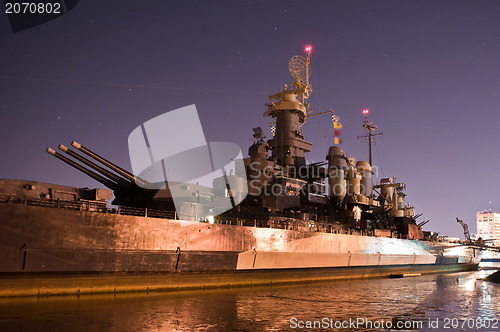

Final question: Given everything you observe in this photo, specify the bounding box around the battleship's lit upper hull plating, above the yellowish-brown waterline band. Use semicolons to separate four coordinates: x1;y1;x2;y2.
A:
0;204;479;275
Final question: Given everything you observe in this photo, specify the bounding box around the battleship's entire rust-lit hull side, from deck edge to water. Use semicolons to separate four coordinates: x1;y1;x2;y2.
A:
0;203;480;296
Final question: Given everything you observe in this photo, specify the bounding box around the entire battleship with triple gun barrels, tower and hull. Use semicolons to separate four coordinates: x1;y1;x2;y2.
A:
0;48;480;297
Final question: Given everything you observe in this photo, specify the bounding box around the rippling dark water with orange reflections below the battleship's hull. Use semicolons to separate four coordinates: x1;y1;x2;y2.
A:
0;271;500;331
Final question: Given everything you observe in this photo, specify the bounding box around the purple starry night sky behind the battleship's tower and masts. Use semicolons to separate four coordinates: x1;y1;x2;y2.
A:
0;0;500;237
